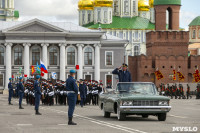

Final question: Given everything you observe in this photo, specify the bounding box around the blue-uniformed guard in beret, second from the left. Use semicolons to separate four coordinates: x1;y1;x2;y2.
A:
18;77;24;109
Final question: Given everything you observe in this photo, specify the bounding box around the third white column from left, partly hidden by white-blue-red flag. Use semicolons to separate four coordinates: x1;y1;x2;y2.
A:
41;43;49;79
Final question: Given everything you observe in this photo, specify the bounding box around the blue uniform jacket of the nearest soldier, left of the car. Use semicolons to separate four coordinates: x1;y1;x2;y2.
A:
66;76;78;94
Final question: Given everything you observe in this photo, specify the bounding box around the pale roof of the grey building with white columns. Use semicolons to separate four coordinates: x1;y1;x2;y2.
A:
0;19;128;43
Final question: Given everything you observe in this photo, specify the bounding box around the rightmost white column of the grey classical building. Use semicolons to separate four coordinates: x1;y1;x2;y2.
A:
94;44;101;82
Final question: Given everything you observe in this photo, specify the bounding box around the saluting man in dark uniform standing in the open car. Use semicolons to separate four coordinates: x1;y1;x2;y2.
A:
112;63;132;82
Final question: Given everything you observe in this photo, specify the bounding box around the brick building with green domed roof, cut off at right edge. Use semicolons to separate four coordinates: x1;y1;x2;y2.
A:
189;16;200;55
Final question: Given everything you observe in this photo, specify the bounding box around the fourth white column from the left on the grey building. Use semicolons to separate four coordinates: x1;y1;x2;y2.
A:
59;43;66;81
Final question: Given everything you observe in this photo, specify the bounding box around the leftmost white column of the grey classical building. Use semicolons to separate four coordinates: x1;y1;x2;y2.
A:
5;43;13;89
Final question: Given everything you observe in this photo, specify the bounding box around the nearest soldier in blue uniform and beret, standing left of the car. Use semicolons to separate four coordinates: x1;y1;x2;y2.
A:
66;70;78;125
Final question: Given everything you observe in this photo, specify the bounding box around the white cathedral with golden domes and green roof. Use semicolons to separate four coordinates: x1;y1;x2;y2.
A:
78;0;155;57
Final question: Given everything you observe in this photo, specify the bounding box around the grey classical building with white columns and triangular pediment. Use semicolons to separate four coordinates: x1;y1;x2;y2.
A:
0;19;127;89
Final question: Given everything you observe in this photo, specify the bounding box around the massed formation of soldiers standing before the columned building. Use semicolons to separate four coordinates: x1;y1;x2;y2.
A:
24;79;104;107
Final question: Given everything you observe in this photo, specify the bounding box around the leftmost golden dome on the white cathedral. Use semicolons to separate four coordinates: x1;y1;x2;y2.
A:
78;0;94;10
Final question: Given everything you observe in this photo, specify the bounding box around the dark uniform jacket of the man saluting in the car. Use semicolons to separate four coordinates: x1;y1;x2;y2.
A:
112;68;132;82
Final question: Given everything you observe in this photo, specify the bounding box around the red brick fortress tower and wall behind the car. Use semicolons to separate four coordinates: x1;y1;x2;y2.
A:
129;0;200;86
